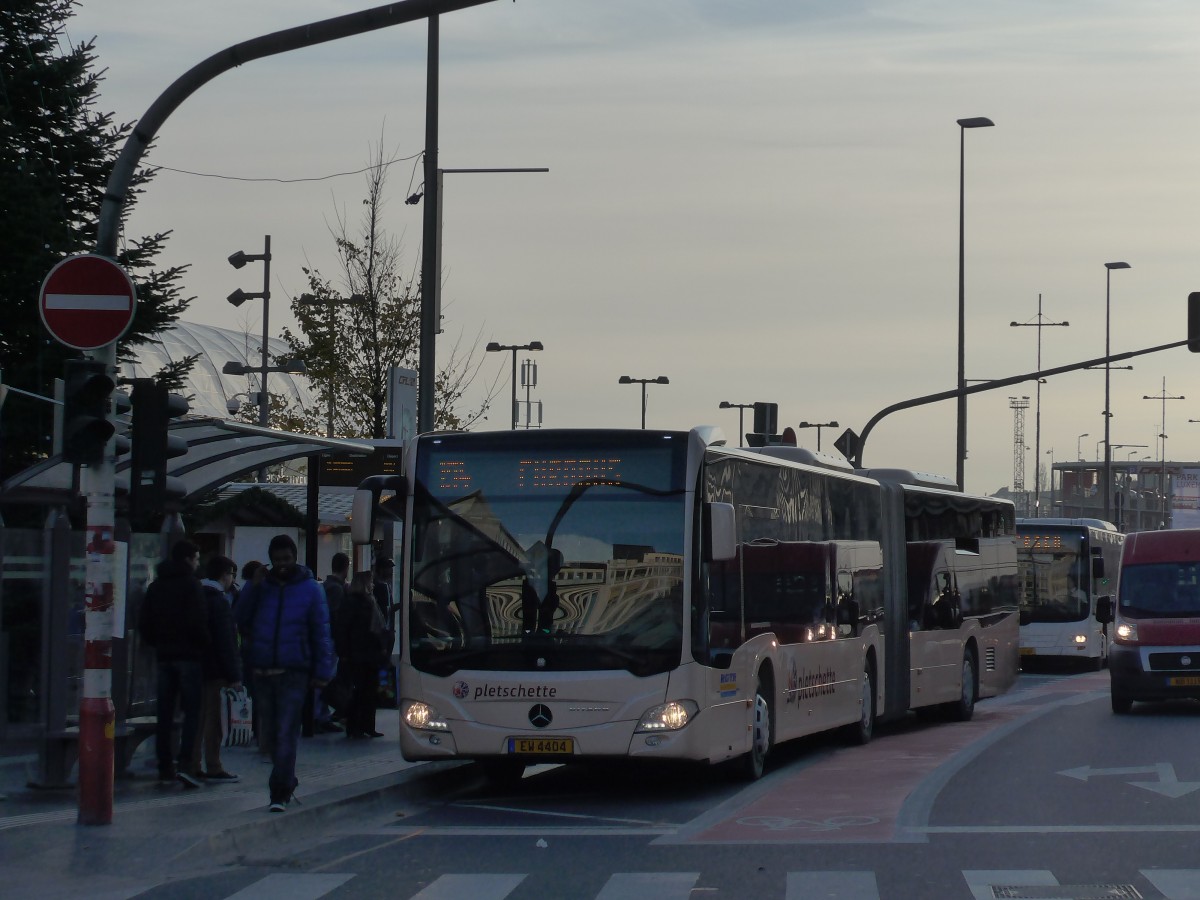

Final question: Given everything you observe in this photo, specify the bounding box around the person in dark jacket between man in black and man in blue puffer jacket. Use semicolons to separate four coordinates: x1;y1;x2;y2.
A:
192;557;241;782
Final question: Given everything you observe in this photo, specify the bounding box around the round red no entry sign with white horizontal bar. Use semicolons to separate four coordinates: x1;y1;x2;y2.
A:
38;253;136;350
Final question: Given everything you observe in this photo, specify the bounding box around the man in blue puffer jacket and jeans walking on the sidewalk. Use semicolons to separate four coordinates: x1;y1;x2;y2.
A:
234;534;337;812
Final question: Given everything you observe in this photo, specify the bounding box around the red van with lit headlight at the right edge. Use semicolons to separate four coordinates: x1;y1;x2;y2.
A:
1109;528;1200;714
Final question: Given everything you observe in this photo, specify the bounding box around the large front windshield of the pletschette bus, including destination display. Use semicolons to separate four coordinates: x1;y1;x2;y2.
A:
408;432;686;676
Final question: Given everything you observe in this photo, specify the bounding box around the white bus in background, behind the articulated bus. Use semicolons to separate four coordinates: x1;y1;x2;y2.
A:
1016;518;1124;670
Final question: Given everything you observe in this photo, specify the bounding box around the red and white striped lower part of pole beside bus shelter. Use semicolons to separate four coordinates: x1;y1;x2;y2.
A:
77;344;116;824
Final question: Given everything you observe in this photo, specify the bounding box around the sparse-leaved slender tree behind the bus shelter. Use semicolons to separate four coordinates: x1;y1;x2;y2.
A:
283;142;496;438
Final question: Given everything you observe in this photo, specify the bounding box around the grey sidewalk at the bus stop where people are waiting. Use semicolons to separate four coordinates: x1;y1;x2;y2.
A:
0;709;457;900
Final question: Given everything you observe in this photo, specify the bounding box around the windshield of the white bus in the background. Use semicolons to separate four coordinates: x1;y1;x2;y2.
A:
1016;532;1091;623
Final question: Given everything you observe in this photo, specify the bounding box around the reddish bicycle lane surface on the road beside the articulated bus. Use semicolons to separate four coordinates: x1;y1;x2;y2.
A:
655;679;1094;844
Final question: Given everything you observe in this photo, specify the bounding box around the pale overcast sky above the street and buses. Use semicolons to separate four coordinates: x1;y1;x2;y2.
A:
60;0;1200;493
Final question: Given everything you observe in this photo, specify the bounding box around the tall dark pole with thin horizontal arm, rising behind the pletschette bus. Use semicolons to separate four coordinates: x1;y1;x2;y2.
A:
404;169;550;432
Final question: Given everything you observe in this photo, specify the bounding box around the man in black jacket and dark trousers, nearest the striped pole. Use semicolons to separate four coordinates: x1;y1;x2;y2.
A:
138;540;210;787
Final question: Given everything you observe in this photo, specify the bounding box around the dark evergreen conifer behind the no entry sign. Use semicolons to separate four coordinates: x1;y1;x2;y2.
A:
0;0;191;476
